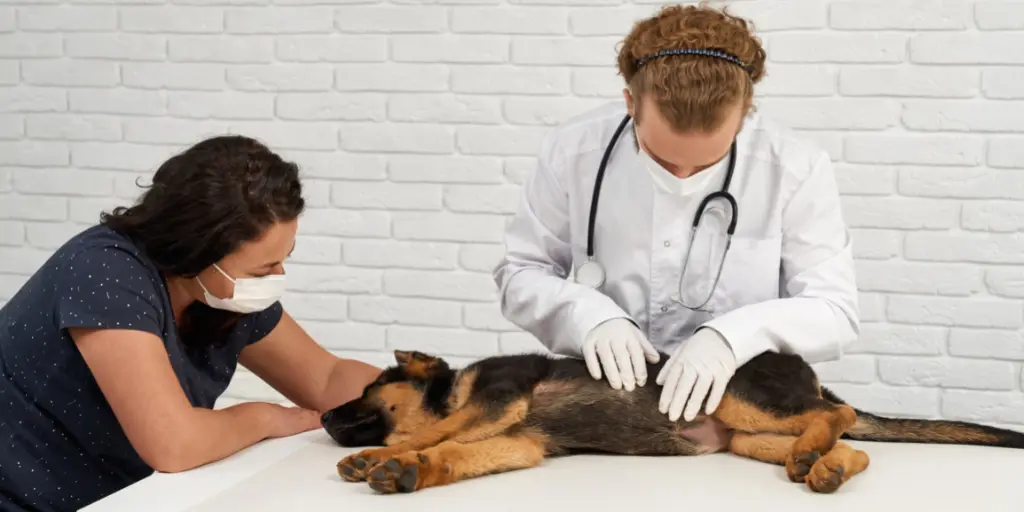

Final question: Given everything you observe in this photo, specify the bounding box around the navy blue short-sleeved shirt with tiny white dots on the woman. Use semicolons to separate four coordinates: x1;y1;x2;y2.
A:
0;226;282;512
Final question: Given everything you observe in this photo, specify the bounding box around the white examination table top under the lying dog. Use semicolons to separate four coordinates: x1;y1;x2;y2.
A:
83;430;1024;512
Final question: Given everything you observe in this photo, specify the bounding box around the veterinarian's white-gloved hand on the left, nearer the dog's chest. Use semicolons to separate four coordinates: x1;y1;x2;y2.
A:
583;318;660;391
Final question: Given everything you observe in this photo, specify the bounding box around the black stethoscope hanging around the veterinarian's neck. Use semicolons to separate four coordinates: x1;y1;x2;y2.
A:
575;115;737;309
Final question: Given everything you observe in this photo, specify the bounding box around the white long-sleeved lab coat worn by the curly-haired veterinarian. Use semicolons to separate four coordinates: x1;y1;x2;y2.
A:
494;102;859;365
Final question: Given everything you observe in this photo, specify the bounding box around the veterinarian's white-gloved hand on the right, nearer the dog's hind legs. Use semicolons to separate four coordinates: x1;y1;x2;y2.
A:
654;328;736;421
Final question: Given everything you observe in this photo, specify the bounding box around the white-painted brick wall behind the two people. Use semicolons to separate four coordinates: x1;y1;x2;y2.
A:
0;0;1024;427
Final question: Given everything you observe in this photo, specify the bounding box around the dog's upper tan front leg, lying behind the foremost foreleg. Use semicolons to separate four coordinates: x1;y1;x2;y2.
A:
338;398;529;481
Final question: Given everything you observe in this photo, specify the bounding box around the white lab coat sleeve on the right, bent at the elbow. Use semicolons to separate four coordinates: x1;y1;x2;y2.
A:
703;155;860;365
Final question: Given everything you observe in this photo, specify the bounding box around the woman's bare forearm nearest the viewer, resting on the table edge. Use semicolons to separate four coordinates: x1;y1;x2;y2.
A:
147;402;275;473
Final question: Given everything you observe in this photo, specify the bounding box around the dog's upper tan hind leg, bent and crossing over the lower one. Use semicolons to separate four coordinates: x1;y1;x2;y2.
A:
714;394;857;482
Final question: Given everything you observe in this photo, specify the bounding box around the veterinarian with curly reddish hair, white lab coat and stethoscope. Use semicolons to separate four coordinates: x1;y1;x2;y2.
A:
495;6;859;420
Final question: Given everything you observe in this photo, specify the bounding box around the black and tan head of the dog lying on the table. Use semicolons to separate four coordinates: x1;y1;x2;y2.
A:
321;350;455;446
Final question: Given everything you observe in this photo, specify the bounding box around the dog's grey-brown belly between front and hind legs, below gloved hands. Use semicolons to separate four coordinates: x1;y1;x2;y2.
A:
525;380;730;455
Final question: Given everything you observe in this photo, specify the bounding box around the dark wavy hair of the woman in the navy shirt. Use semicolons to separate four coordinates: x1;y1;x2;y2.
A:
100;135;305;345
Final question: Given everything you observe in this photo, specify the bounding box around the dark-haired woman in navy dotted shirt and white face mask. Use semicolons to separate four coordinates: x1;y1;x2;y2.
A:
0;136;380;512
